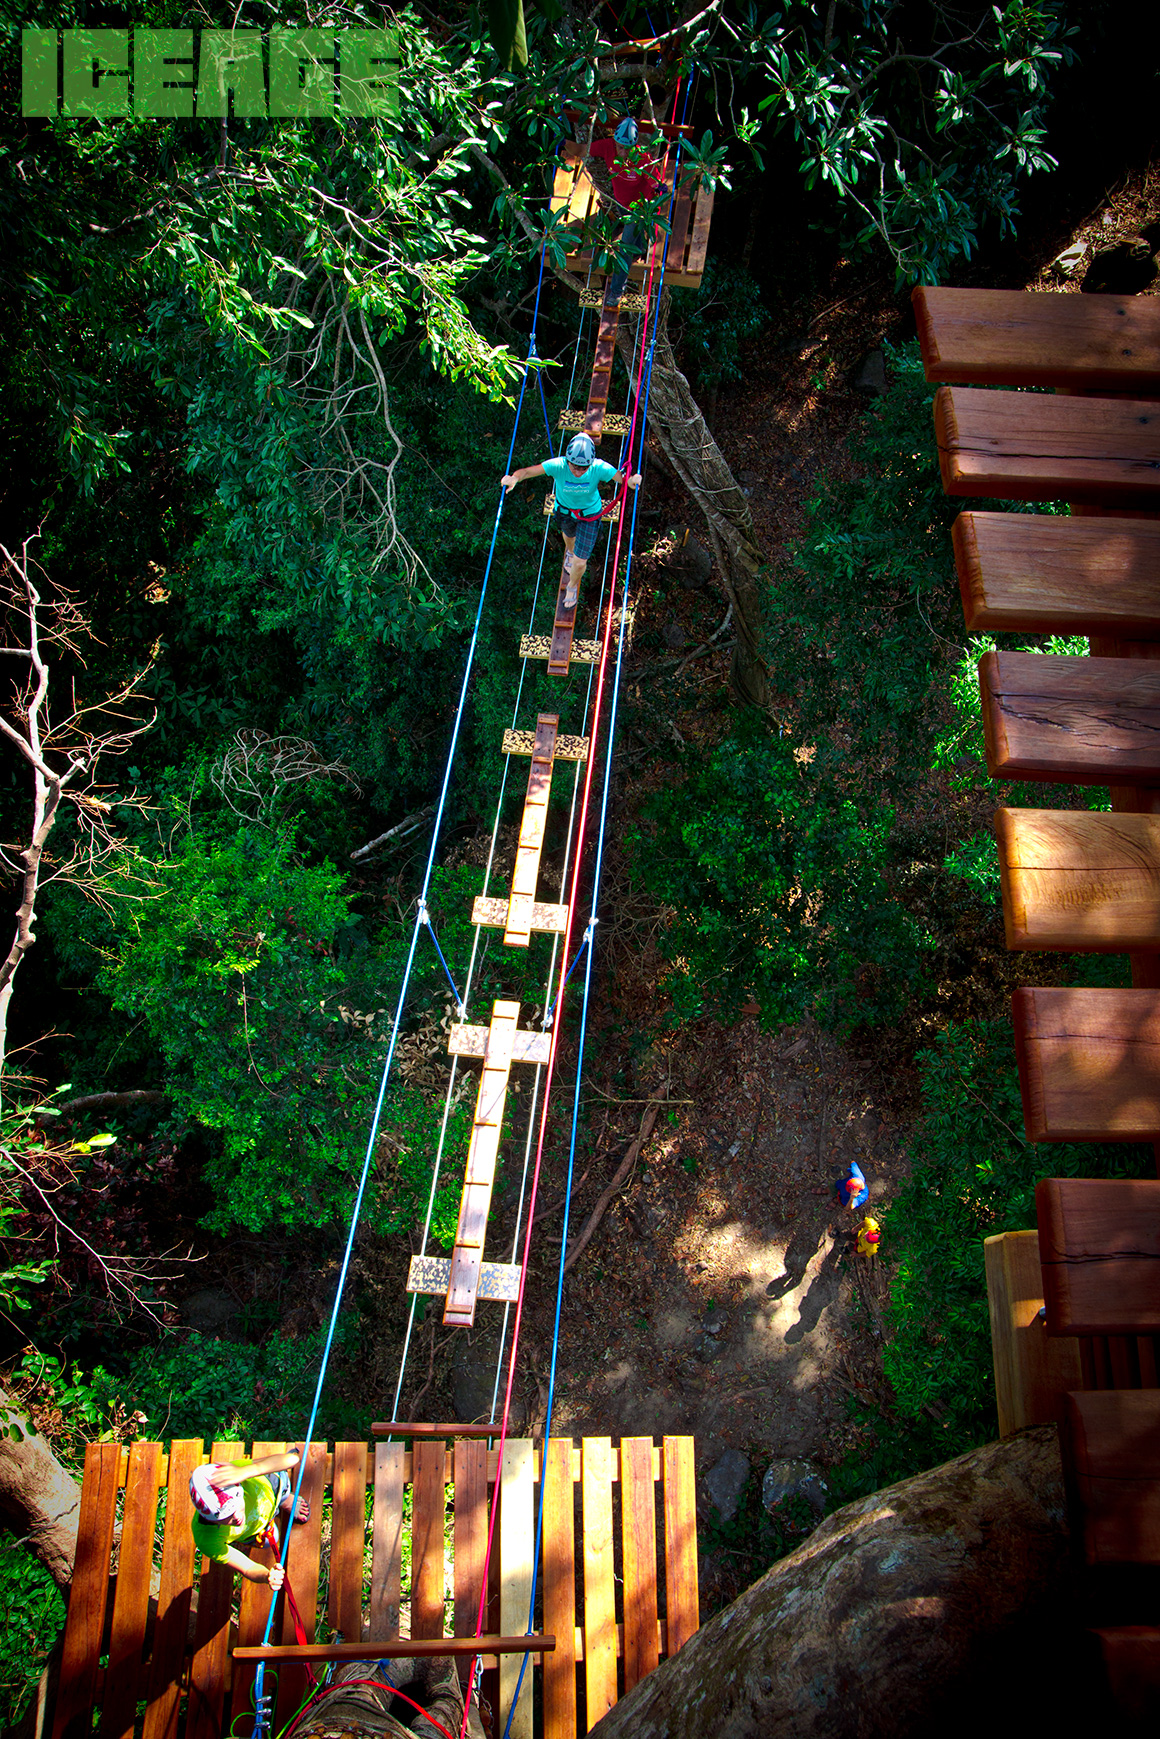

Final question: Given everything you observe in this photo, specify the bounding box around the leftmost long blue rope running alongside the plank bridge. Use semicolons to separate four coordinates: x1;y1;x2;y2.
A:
254;247;544;1739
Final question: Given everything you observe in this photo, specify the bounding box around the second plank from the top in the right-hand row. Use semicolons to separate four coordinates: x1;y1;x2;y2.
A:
934;386;1160;506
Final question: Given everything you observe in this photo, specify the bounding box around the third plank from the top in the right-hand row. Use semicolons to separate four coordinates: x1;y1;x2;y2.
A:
951;507;1160;640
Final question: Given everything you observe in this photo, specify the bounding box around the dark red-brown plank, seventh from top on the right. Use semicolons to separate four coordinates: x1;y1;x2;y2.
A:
1035;1177;1160;1335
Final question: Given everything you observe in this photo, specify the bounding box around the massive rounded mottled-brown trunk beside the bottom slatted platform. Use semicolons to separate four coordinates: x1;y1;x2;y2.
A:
593;1426;1108;1739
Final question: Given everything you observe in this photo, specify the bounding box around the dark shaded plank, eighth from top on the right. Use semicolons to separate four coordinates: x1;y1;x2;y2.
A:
1059;1389;1160;1565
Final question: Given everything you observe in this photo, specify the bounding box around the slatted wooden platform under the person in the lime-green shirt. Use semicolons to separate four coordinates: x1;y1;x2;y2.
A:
50;1436;699;1739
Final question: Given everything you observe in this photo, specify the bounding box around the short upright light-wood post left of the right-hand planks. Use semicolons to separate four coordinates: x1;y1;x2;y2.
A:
983;1231;1083;1436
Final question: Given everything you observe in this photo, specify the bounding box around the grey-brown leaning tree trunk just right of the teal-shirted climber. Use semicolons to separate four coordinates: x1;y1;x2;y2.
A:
617;290;769;708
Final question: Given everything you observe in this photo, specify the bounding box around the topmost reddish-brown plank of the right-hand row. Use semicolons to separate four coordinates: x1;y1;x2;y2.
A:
911;285;1160;393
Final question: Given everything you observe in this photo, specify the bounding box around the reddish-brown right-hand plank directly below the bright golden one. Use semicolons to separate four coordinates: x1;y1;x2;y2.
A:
1012;986;1160;1141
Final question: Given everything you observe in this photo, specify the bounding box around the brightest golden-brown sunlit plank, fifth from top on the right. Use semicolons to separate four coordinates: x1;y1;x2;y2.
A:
995;809;1160;953
